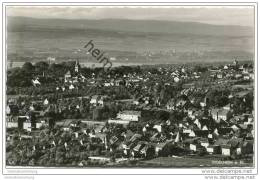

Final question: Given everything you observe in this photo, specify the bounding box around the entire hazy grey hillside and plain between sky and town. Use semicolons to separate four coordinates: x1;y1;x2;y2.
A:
7;17;254;64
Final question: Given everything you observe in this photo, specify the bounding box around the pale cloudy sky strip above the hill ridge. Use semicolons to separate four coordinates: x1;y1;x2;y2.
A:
7;6;254;27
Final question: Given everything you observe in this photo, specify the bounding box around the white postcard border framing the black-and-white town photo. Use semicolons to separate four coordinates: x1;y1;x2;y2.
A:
0;1;258;178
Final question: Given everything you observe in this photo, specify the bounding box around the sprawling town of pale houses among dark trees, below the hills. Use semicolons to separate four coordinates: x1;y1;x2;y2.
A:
6;57;255;167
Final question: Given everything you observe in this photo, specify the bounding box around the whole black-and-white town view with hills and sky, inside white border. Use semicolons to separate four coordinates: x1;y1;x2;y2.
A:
5;6;255;168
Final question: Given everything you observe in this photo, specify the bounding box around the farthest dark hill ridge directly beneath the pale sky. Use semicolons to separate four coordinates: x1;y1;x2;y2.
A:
8;17;253;36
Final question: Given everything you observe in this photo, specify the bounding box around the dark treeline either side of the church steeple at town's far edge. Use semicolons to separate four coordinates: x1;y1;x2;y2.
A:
7;61;144;87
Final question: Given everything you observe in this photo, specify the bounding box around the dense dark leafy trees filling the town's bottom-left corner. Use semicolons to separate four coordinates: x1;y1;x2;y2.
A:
6;128;104;166
